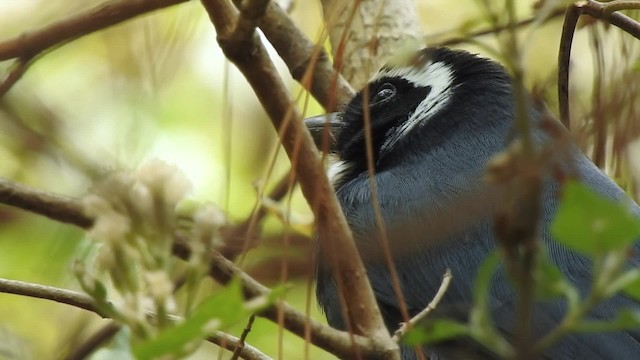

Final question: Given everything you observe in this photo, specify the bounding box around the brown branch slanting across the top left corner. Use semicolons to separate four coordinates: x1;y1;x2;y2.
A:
0;0;188;61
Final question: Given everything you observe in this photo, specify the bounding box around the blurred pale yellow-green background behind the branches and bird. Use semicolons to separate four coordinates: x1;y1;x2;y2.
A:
0;0;640;359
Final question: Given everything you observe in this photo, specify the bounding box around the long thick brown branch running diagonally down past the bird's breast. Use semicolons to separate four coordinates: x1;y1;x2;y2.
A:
202;0;399;358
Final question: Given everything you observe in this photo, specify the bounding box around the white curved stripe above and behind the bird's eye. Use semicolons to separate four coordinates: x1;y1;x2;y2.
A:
371;62;453;155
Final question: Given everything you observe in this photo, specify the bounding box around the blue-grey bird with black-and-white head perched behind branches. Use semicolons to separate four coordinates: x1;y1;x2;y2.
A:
305;47;640;360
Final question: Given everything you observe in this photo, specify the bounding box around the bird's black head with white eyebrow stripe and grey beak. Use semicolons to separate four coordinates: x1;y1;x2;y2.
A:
306;47;513;188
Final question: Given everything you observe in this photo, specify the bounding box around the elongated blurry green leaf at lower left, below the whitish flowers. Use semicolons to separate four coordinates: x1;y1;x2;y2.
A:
133;279;250;360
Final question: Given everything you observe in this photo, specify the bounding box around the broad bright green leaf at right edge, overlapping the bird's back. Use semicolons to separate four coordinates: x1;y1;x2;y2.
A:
551;181;640;256
